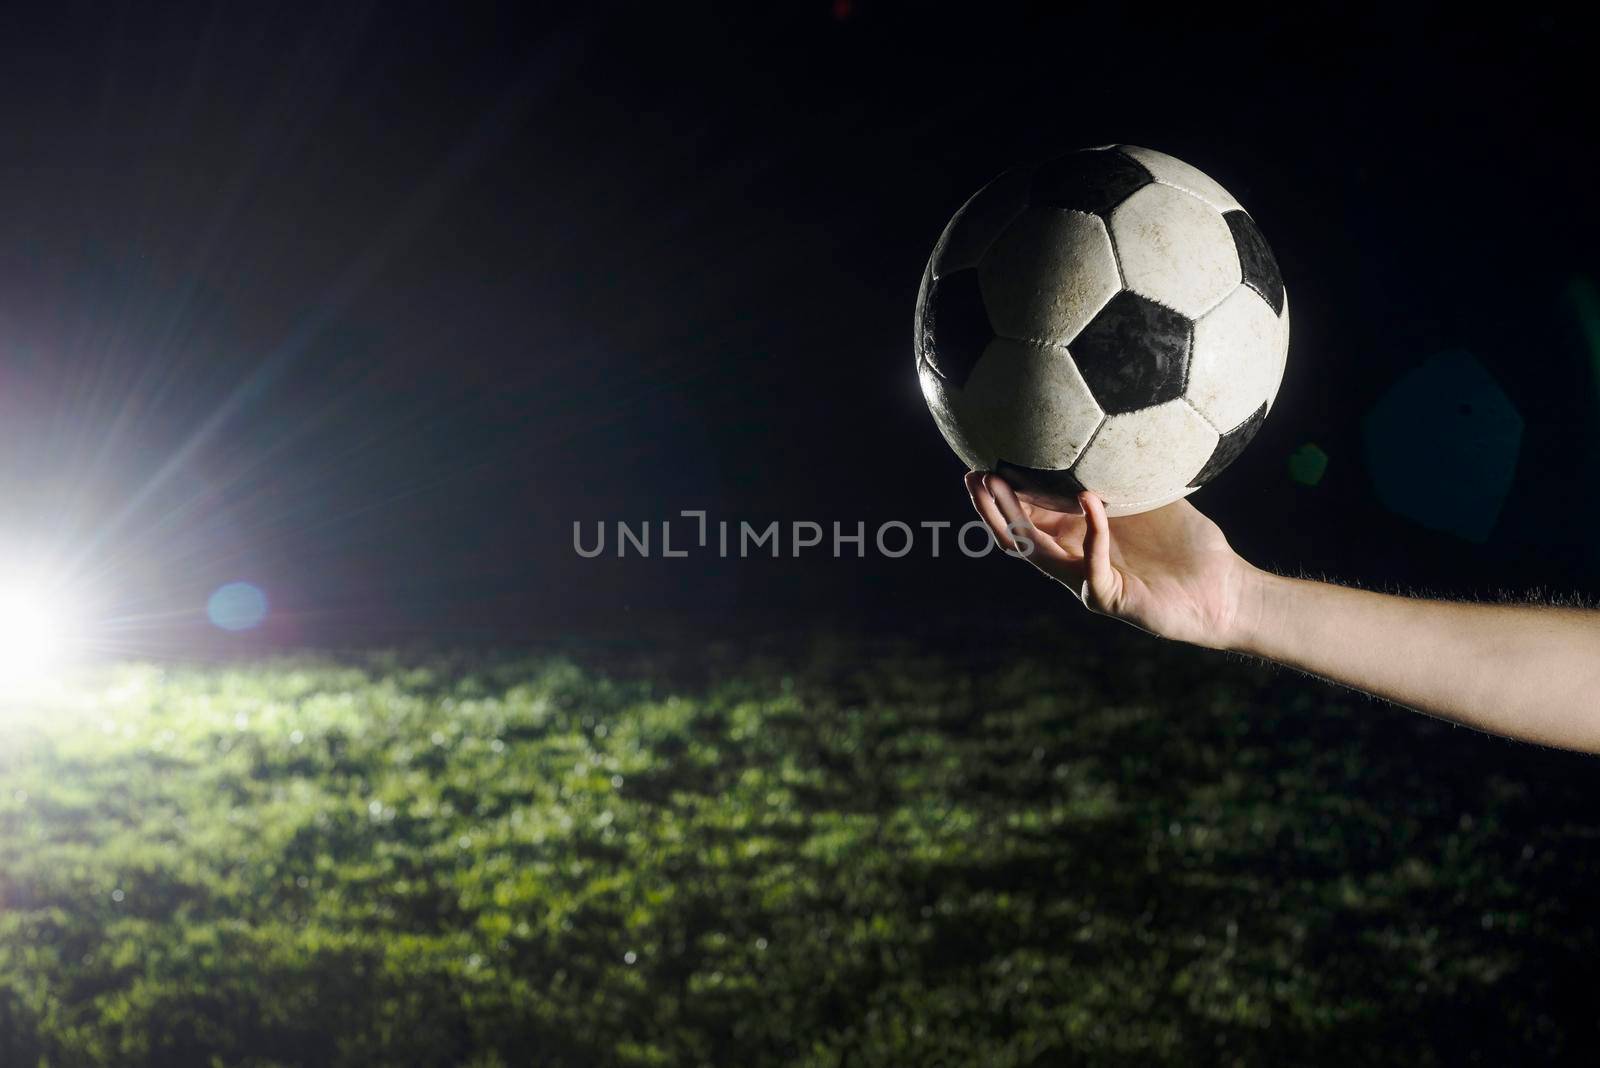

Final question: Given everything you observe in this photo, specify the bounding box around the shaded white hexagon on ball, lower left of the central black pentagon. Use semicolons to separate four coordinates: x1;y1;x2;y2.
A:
955;337;1102;470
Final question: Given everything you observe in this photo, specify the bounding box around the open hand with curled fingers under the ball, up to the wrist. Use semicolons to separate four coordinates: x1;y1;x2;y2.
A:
966;472;1261;649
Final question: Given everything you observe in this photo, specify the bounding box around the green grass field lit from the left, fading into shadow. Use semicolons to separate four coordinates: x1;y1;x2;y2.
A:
0;619;1600;1066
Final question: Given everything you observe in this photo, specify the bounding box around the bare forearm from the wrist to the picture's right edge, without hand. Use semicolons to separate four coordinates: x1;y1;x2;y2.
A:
1229;568;1600;751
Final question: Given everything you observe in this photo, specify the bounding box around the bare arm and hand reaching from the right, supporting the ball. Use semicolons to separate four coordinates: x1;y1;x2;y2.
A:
966;472;1600;753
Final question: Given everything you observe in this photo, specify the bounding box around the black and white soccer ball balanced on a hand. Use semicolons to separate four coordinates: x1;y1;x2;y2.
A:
915;145;1290;515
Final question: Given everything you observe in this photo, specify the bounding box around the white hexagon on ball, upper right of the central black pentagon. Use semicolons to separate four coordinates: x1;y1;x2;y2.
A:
1110;185;1242;318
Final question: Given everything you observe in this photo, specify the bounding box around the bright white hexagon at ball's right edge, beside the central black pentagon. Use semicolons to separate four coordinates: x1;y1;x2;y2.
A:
1184;286;1283;433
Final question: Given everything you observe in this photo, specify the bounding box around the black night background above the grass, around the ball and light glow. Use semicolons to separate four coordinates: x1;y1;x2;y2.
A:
0;2;1600;649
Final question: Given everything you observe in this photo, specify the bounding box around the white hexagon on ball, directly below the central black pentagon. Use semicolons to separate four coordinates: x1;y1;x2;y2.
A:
1072;398;1222;510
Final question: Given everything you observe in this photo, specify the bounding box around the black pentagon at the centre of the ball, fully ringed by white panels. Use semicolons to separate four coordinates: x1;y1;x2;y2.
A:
1067;289;1194;416
